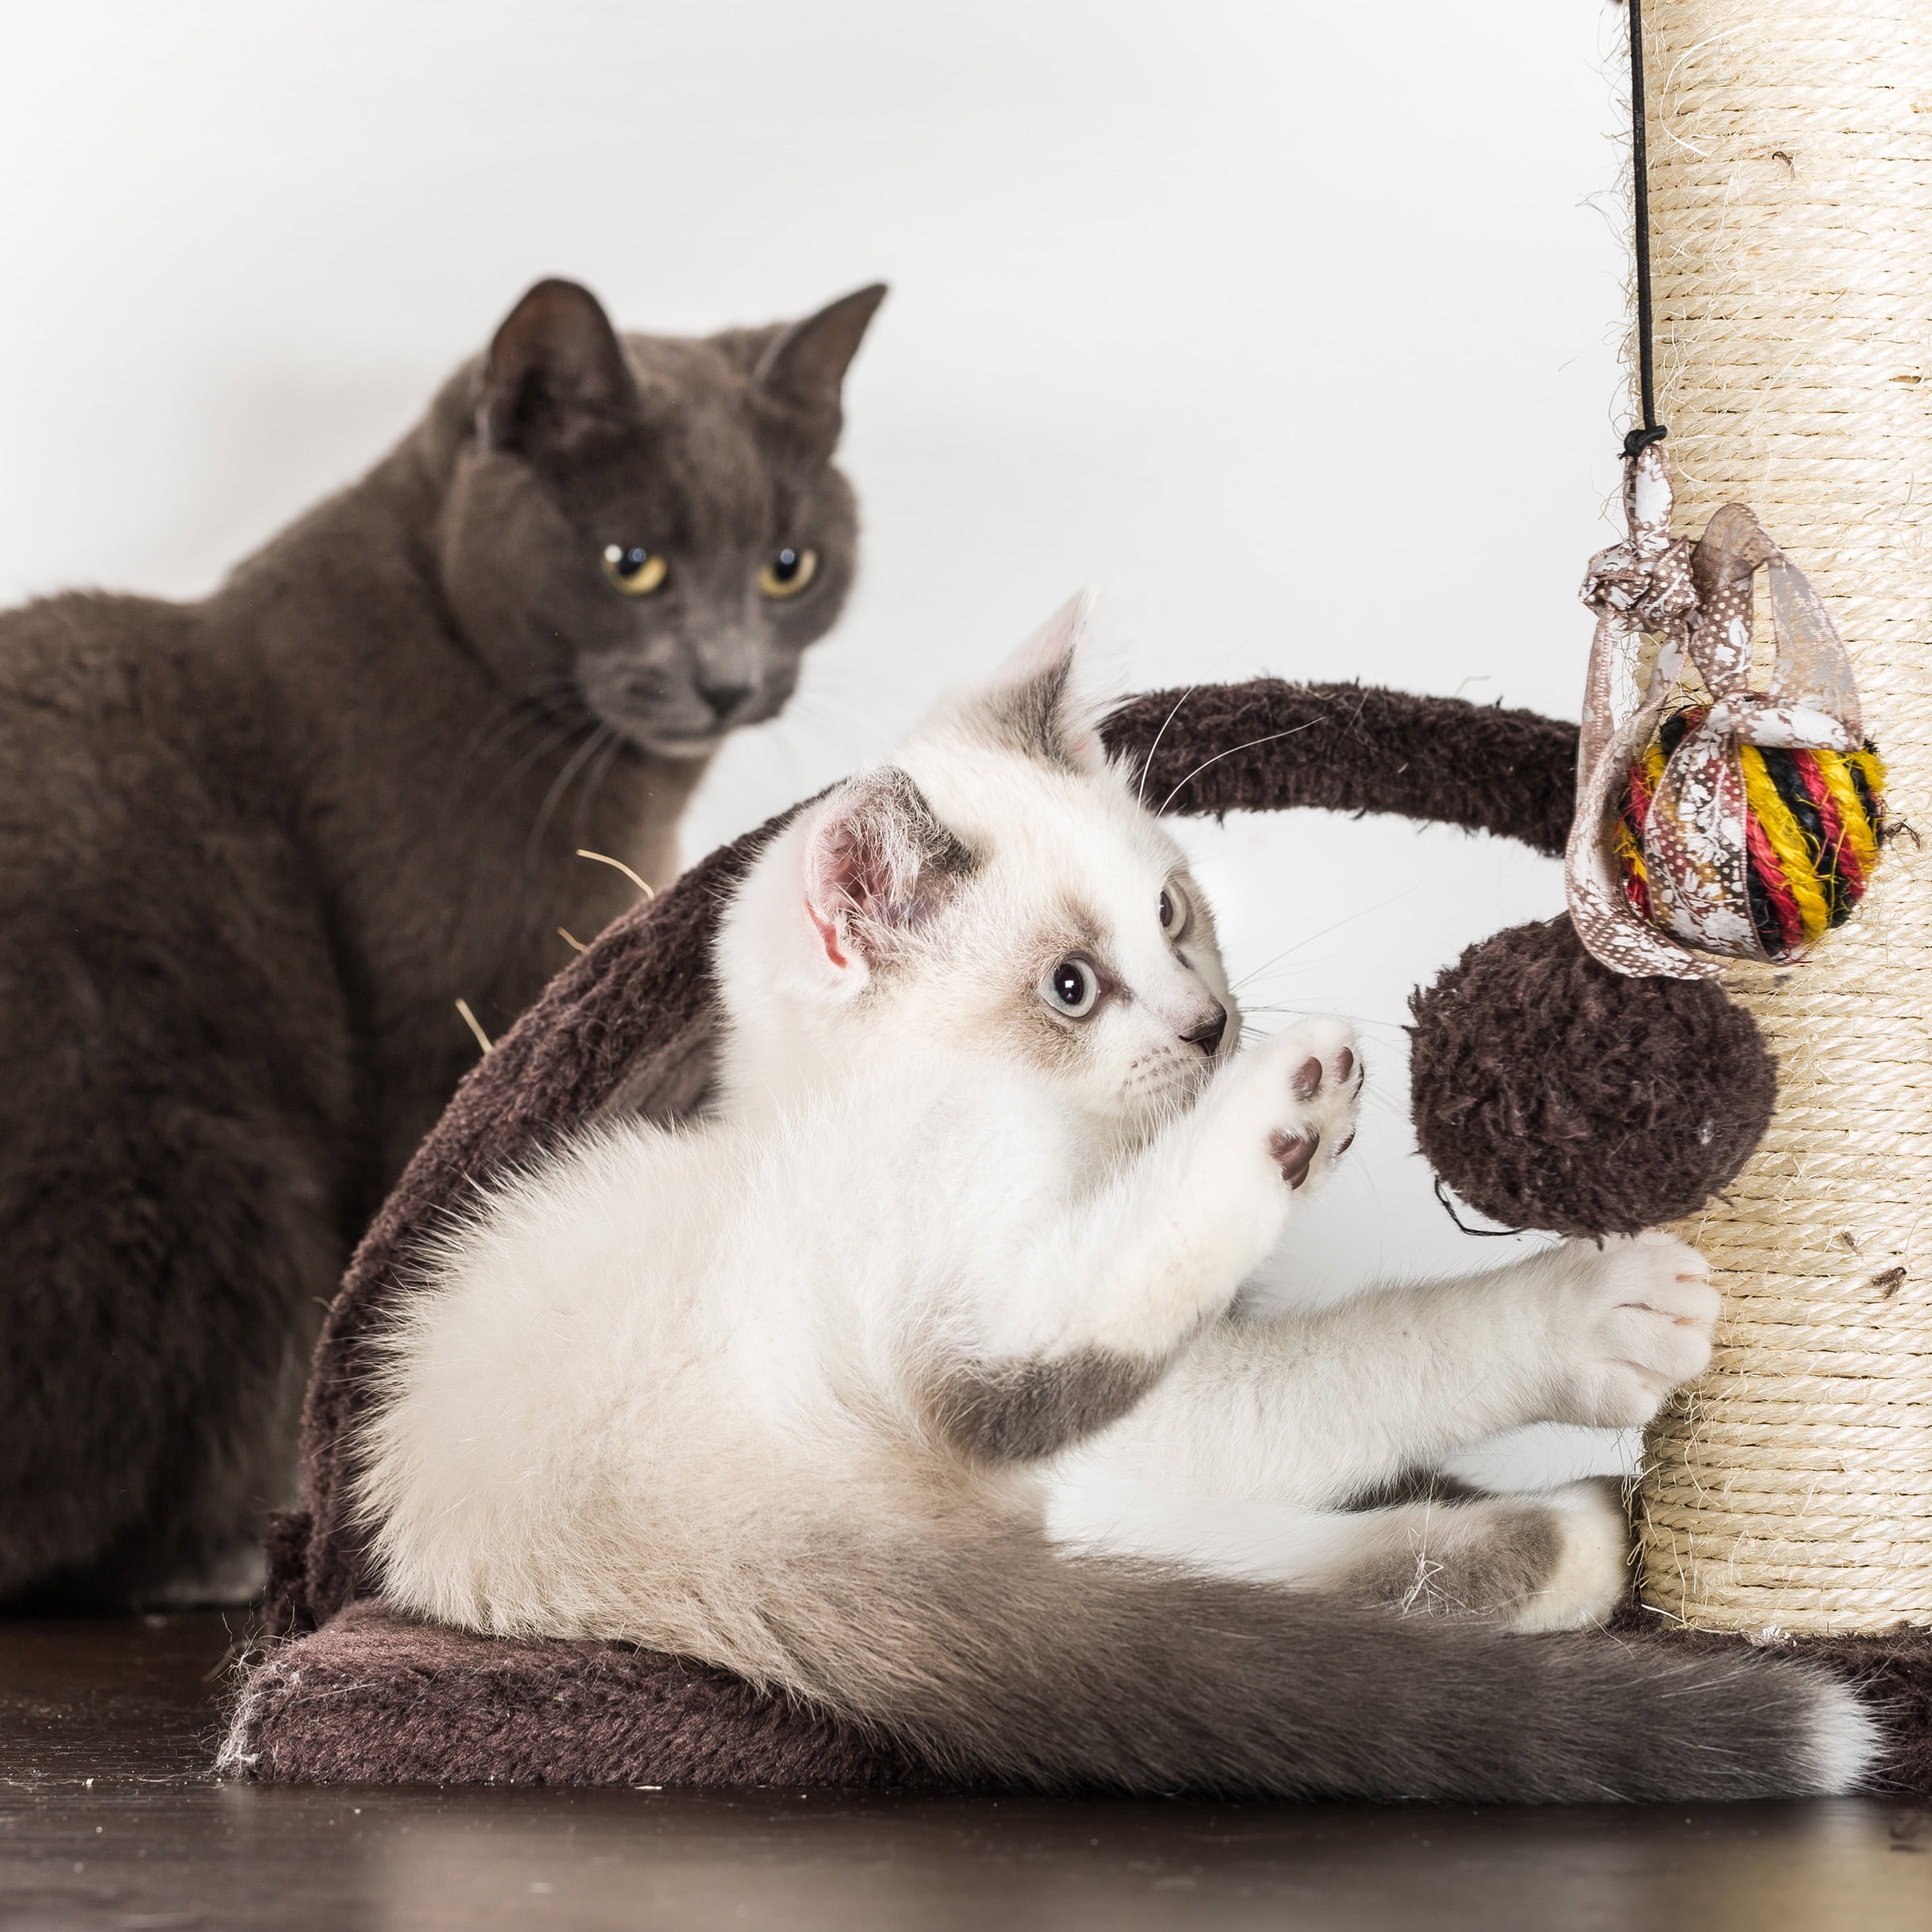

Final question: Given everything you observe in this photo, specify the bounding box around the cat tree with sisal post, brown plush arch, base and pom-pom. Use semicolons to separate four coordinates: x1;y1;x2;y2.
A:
222;0;1932;1793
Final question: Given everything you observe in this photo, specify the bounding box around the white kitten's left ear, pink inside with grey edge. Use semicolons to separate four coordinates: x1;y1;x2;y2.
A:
803;767;974;977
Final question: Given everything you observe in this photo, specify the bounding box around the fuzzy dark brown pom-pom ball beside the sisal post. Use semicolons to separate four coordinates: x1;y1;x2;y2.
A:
1409;918;1777;1235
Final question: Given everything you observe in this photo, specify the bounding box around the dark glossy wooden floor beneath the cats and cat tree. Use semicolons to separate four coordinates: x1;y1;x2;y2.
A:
0;1615;1932;1932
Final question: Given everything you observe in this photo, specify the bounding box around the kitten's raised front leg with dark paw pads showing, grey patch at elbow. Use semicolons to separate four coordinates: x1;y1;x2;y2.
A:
923;1018;1362;1460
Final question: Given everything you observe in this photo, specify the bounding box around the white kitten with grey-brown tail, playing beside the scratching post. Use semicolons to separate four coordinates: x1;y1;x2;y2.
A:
359;607;1868;1798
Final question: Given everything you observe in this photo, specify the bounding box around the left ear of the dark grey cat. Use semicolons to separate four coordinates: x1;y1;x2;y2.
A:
477;279;638;464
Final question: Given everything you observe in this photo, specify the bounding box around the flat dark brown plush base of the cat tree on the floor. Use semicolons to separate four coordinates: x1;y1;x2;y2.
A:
222;1598;1932;1797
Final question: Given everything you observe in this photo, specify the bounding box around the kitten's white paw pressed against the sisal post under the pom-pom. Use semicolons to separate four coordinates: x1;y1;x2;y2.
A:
1550;1228;1719;1430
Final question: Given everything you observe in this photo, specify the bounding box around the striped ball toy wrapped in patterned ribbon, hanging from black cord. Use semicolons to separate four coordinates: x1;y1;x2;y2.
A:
1567;443;1885;980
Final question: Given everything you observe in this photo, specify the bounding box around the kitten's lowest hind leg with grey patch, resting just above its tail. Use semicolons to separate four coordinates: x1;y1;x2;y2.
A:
1296;1478;1631;1631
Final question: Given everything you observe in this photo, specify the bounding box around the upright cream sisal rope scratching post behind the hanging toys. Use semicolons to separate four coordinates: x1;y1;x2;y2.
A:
1638;0;1932;1633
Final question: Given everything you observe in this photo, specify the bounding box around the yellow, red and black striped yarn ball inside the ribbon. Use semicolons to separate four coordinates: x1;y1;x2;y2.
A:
1615;707;1885;960
